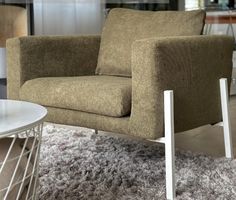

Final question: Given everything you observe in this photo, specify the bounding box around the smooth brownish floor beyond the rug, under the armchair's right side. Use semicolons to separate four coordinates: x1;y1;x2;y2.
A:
175;96;236;157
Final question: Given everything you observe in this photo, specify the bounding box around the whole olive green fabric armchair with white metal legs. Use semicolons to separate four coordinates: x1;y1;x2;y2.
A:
7;9;233;199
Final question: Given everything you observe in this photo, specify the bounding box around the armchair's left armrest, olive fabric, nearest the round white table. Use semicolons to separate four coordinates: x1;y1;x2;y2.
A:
7;36;100;99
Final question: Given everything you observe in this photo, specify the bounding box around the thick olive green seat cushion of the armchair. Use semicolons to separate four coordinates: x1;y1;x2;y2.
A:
20;76;131;117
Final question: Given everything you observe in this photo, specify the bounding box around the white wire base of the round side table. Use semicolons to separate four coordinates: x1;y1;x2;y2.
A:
0;123;43;200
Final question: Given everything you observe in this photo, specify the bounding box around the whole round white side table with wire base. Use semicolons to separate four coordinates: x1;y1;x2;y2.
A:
0;100;47;200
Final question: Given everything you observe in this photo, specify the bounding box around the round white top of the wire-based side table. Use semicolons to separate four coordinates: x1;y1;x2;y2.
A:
0;99;47;137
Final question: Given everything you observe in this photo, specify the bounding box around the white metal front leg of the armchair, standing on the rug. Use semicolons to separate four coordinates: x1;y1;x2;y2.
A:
164;90;176;200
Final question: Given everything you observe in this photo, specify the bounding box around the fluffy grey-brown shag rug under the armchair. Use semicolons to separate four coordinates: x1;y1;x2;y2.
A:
39;124;236;200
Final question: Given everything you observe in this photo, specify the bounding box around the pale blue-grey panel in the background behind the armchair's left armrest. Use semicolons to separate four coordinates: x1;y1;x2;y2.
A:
34;0;104;35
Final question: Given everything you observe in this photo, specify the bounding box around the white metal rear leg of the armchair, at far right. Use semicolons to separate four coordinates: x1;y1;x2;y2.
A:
220;78;234;158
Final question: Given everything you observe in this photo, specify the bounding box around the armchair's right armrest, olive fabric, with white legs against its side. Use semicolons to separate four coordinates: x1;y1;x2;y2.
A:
129;36;233;139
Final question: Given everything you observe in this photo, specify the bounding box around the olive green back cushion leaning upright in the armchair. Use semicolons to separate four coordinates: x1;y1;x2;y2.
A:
96;8;205;77
